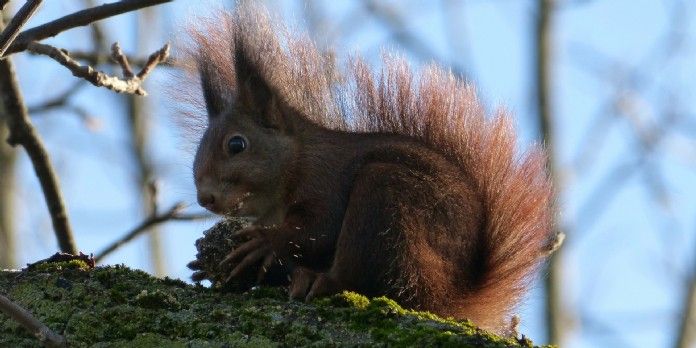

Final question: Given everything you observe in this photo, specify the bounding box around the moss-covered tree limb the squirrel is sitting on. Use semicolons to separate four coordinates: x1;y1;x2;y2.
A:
0;262;544;347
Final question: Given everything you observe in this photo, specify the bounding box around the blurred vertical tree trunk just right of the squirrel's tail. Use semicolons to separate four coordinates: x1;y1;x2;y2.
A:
534;0;566;347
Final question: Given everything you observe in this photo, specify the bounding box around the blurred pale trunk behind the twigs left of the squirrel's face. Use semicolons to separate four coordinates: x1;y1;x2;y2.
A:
127;9;167;277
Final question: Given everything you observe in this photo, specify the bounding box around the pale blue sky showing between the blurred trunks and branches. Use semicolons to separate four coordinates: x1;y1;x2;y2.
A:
6;0;696;347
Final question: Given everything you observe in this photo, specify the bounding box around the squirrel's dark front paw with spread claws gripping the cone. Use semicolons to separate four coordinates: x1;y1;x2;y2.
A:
220;226;276;283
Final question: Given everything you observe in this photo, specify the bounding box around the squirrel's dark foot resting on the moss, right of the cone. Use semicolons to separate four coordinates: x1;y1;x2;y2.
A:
289;267;344;301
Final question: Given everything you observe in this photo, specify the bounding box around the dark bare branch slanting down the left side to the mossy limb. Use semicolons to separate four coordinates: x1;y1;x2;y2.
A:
0;59;77;254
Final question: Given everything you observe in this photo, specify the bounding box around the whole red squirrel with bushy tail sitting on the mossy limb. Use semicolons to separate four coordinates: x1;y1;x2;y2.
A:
190;6;551;330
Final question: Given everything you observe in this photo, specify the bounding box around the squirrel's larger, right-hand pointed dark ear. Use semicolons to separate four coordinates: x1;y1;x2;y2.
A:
234;44;288;130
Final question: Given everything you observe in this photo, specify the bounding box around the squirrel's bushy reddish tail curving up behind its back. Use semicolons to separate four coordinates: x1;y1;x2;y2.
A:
352;57;552;327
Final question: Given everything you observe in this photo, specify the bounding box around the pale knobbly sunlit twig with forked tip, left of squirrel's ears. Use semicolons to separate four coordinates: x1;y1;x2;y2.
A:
28;42;169;96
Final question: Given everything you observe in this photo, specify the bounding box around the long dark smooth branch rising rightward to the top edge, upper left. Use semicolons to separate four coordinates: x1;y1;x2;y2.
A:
6;0;173;55
